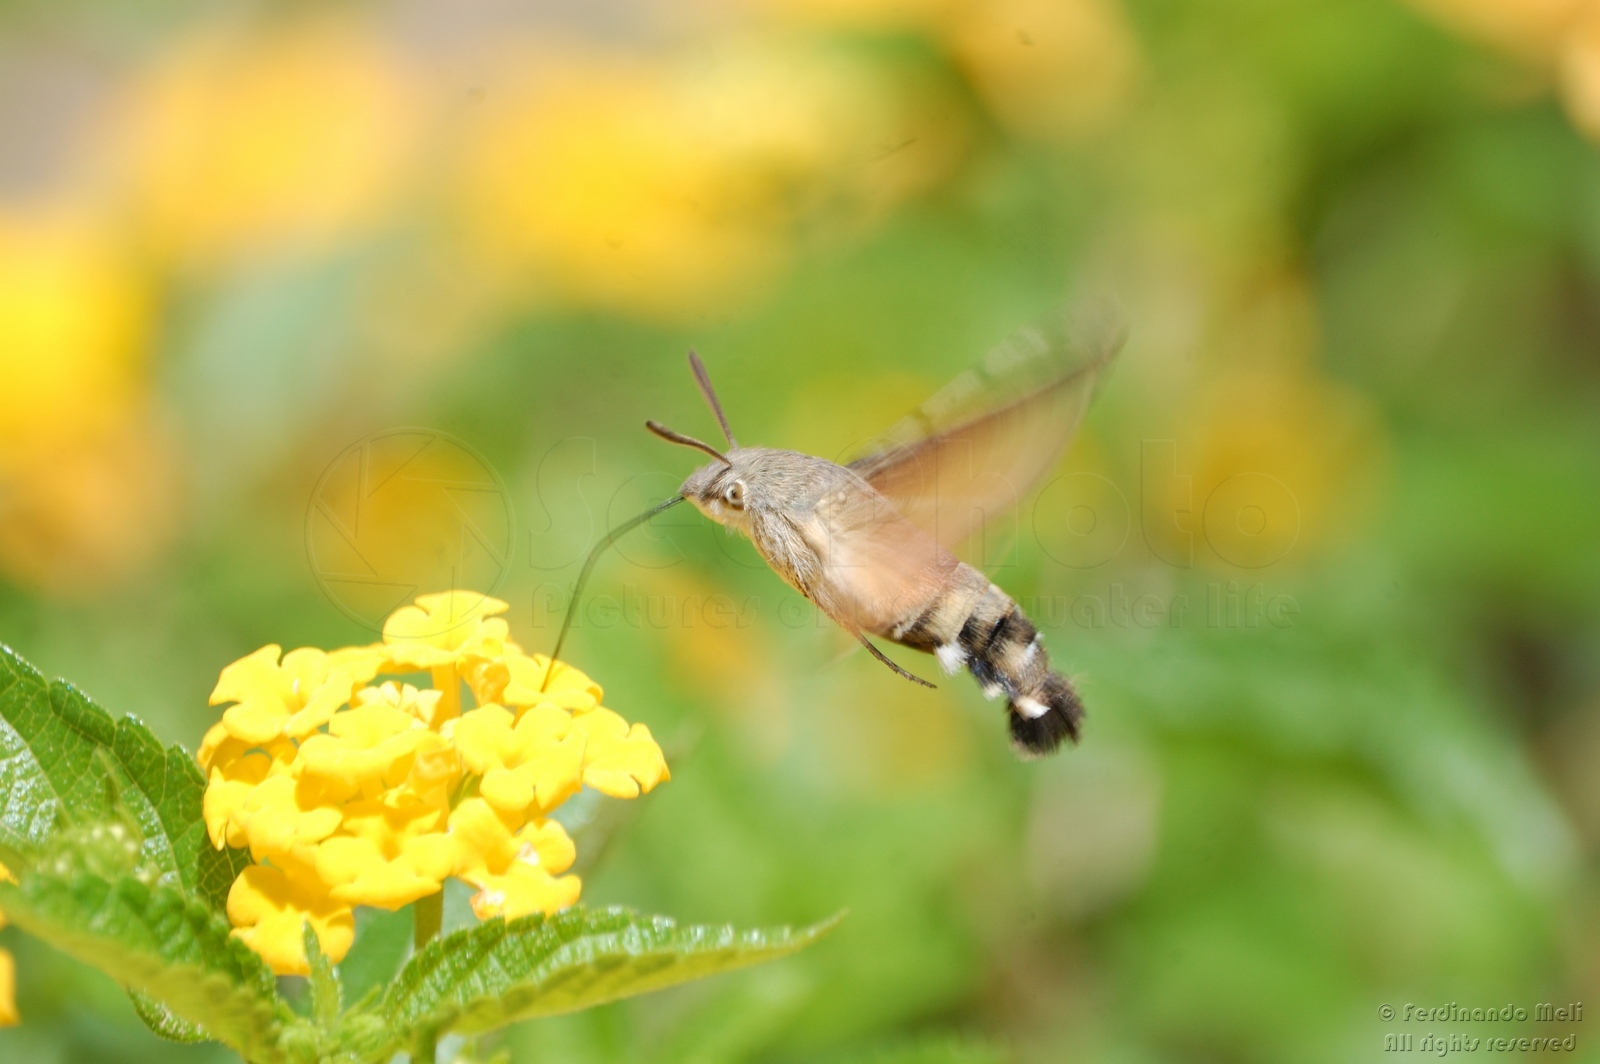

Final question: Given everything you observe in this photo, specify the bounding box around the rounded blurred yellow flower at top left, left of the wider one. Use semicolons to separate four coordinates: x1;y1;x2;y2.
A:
126;21;418;264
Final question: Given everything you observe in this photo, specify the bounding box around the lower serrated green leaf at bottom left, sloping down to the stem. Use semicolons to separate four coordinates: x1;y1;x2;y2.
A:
0;872;293;1061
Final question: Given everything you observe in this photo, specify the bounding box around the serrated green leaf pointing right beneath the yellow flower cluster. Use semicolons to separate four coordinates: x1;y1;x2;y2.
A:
379;907;837;1045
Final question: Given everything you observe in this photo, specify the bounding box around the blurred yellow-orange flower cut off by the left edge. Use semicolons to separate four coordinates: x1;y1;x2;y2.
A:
0;205;174;589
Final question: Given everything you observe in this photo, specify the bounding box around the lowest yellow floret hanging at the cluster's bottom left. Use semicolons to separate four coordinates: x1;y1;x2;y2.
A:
227;864;355;976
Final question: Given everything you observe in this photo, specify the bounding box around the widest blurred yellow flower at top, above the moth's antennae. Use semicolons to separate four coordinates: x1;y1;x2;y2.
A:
459;45;960;318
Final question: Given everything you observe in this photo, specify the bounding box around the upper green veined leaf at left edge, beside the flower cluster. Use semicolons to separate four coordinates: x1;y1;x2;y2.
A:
0;645;248;912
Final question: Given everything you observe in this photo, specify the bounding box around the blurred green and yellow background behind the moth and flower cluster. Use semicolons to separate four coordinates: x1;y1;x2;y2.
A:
0;0;1600;1064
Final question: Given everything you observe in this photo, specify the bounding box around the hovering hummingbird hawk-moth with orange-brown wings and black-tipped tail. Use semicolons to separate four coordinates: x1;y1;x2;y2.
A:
646;309;1122;757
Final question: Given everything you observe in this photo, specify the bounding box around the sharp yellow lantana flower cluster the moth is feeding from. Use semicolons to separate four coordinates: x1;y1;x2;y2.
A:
198;590;669;974
